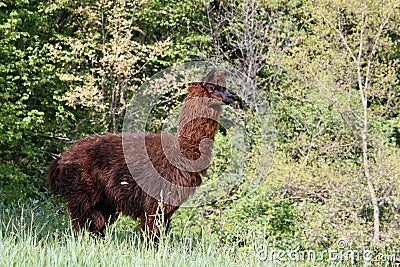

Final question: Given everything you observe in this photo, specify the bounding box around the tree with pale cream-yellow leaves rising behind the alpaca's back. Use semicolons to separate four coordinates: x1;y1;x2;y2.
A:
53;0;209;132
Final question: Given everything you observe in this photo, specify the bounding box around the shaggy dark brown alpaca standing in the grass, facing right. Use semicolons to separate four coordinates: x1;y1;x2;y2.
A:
47;72;238;236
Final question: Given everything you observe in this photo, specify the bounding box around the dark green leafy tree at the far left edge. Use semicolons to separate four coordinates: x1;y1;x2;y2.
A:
0;0;71;201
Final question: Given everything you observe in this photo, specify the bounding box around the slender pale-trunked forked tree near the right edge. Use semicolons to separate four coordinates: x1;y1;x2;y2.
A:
310;1;400;245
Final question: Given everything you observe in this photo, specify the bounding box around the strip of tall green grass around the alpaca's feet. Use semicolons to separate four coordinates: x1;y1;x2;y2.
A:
0;202;390;267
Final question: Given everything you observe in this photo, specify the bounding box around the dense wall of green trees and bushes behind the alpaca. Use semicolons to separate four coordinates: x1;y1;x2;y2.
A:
0;0;400;256
